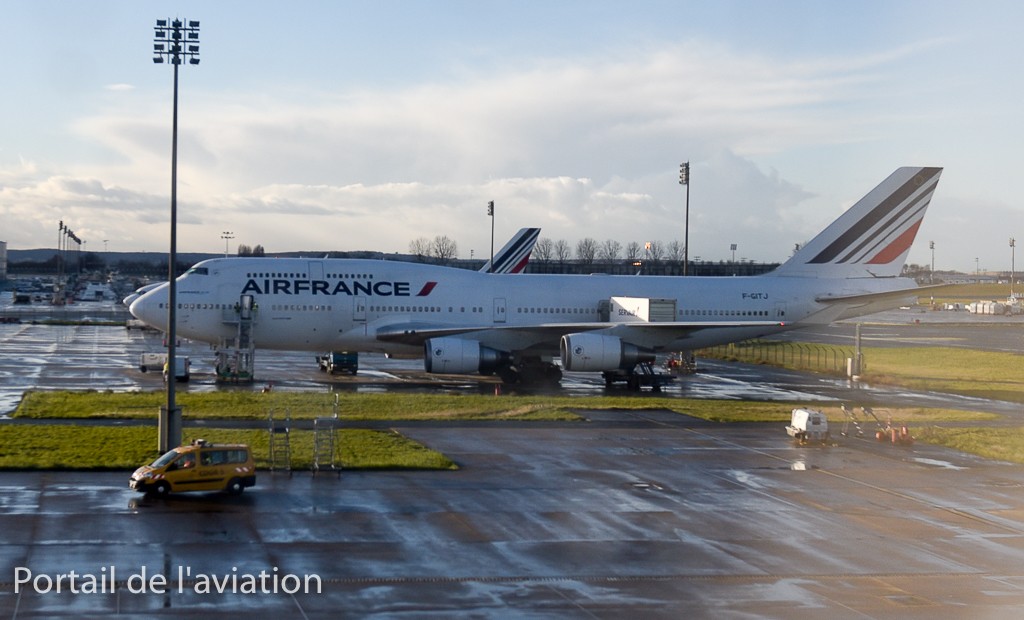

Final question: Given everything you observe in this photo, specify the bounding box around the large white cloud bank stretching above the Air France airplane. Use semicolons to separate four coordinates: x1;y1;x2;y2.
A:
6;41;966;260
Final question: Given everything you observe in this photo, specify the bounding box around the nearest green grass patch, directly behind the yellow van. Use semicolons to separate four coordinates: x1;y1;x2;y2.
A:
0;424;458;469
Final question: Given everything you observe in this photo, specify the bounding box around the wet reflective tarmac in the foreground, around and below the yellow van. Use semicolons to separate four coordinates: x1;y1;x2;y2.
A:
0;411;1024;620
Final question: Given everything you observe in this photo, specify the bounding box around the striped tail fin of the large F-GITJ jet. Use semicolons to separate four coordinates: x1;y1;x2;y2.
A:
773;167;942;278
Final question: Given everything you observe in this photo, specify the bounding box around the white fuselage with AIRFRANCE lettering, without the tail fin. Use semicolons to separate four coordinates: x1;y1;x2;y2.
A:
131;258;912;355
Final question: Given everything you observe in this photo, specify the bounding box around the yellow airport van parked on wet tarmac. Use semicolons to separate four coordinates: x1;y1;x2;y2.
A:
128;440;256;495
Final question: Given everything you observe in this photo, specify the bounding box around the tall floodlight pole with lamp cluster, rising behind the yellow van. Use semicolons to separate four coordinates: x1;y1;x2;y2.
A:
153;18;199;452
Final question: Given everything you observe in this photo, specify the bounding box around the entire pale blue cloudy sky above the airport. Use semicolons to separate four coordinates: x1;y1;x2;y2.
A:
0;0;1024;272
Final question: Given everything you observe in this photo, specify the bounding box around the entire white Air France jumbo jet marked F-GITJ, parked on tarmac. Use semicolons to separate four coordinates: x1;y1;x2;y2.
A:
130;167;942;382
